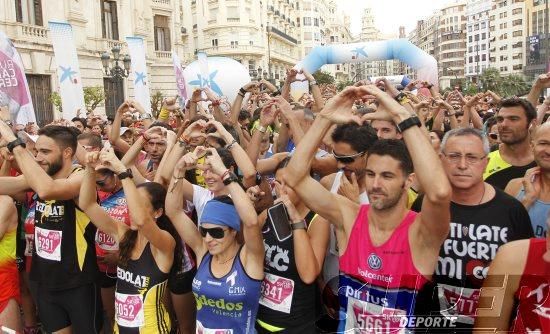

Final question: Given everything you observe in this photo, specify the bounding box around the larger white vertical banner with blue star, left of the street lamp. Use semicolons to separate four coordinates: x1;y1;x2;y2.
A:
48;21;86;120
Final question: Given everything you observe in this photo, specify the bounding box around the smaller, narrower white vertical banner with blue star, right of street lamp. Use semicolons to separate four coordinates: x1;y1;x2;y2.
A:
126;37;151;110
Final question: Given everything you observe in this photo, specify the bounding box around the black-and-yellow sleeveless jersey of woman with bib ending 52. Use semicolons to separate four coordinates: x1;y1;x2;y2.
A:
114;242;170;334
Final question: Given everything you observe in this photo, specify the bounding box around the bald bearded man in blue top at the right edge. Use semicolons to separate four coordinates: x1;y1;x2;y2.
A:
505;123;550;238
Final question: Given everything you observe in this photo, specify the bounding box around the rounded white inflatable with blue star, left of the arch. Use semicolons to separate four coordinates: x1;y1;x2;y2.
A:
183;57;250;103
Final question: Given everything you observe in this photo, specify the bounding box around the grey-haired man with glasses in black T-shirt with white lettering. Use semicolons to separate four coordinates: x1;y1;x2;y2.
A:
414;128;533;331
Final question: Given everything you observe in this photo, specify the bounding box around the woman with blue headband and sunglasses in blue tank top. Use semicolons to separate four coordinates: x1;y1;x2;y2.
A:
166;148;264;334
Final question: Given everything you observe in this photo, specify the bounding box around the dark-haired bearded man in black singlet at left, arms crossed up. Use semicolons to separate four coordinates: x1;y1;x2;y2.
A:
0;121;102;333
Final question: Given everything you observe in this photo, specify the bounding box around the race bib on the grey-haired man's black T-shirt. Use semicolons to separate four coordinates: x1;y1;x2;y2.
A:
437;284;479;325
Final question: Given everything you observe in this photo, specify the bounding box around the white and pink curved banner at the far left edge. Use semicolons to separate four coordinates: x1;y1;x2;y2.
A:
0;31;36;125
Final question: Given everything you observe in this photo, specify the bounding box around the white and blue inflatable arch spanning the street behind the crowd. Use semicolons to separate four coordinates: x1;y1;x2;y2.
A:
296;39;439;85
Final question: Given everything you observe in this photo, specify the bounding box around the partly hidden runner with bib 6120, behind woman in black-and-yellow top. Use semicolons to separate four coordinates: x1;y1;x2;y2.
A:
95;166;130;325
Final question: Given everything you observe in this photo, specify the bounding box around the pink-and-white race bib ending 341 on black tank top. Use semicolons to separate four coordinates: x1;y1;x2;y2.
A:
260;273;294;313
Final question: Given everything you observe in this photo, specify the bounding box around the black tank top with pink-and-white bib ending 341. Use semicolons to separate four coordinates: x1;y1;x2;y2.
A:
257;212;317;334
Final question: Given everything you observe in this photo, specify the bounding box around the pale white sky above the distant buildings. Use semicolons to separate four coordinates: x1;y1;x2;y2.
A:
338;0;452;35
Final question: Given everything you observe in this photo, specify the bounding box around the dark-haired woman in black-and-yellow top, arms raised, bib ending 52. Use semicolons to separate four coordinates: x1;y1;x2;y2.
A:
79;149;181;334
